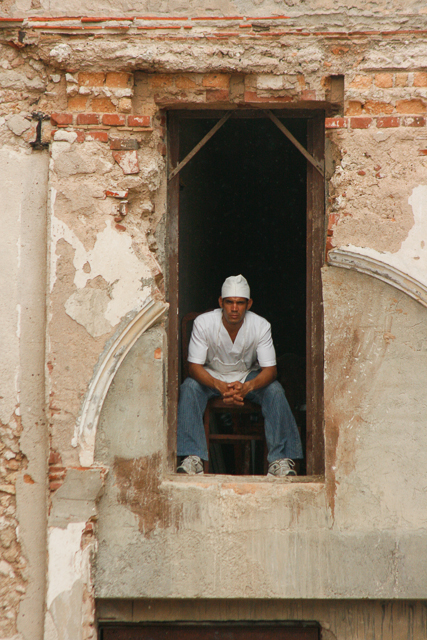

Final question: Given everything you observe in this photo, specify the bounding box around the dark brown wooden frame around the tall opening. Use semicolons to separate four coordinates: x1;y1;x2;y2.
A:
166;106;325;476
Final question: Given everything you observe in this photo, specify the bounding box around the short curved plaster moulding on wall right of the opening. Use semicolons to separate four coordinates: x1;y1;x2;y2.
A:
328;249;427;307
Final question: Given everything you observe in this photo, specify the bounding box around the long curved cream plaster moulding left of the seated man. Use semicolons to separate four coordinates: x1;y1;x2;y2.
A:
72;300;169;467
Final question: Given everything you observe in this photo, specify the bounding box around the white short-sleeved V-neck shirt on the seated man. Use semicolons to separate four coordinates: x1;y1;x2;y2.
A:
188;309;276;382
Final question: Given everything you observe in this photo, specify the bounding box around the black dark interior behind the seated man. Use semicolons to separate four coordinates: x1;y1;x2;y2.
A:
179;113;307;474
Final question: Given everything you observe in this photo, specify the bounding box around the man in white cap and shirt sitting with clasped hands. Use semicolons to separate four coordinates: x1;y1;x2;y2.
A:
177;275;303;476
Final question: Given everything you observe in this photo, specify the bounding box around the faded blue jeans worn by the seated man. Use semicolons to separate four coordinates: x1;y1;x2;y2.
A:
177;371;303;462
